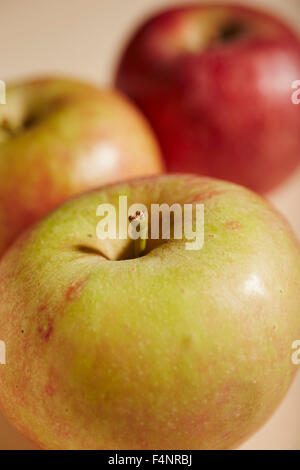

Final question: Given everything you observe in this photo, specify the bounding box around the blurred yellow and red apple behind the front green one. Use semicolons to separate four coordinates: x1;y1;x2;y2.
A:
0;78;163;255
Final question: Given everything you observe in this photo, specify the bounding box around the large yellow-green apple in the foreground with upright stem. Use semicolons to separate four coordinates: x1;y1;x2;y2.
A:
0;175;300;449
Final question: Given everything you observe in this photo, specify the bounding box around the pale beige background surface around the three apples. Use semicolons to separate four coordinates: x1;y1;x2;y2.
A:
0;0;300;449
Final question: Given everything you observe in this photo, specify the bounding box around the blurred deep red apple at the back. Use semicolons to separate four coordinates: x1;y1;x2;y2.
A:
116;5;300;193
